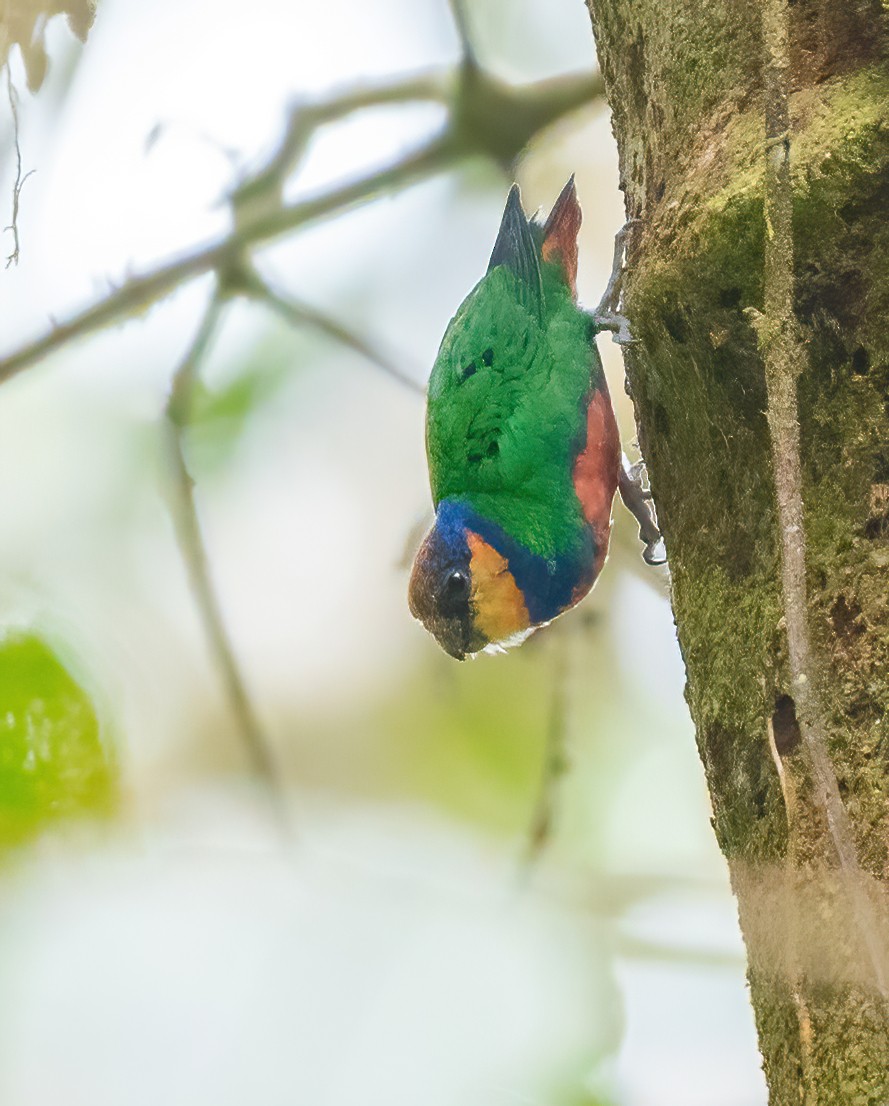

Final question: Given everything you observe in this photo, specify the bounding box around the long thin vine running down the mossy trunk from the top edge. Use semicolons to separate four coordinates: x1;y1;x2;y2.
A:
753;0;889;999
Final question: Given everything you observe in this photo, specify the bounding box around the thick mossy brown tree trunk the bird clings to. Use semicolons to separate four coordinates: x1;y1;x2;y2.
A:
588;0;889;1106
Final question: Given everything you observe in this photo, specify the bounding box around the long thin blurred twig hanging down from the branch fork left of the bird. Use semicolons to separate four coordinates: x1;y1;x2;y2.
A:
165;295;291;837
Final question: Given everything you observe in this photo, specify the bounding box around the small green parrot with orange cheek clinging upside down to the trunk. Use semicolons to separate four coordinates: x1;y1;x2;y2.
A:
408;177;660;660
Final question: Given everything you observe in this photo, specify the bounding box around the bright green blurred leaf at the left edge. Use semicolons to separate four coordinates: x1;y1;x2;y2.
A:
0;636;117;847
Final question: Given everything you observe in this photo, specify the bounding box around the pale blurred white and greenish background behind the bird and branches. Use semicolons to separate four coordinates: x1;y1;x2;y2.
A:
0;0;765;1106
